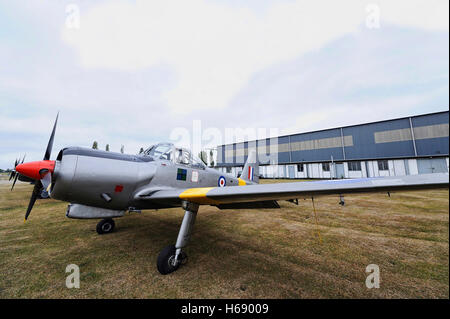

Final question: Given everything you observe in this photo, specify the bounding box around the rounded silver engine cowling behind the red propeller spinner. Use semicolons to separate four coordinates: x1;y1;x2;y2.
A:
51;147;156;210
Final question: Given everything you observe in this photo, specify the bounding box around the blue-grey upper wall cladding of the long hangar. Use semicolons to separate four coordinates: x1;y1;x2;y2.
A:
218;111;449;166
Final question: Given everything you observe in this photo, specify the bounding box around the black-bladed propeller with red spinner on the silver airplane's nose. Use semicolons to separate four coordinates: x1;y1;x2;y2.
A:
10;112;59;220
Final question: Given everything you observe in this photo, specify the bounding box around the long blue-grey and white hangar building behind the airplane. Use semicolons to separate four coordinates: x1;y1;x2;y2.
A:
216;111;449;179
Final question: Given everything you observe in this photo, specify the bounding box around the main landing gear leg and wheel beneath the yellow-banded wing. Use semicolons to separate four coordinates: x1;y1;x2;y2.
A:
156;201;198;275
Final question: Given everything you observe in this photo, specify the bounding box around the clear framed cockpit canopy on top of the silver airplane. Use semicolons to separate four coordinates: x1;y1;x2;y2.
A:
141;143;205;169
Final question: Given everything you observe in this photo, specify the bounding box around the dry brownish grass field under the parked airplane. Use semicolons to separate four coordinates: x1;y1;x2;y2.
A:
0;176;449;298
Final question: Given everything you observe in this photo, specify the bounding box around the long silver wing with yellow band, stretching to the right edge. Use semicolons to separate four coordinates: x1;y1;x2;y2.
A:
135;173;449;205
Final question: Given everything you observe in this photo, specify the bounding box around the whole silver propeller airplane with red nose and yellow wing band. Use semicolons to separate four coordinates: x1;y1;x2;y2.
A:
10;113;449;275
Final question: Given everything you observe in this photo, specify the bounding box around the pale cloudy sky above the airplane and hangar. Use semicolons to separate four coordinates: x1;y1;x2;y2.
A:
0;0;449;169
